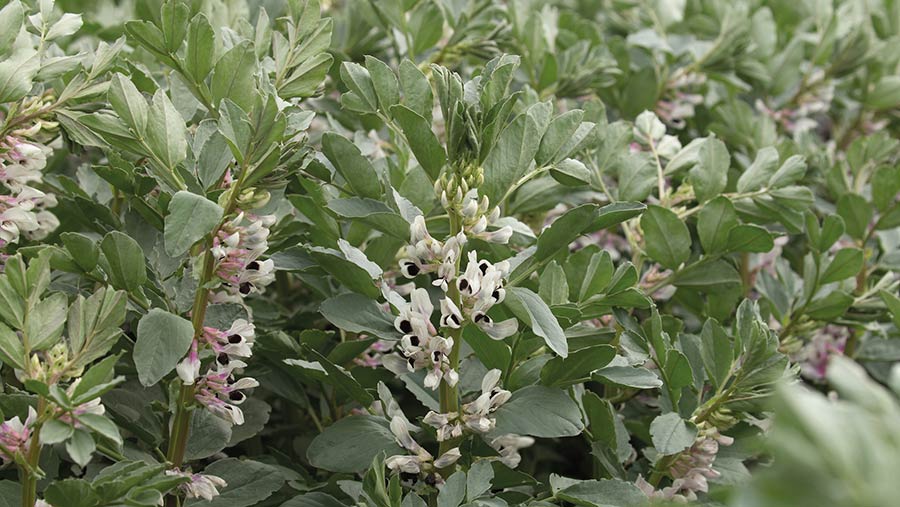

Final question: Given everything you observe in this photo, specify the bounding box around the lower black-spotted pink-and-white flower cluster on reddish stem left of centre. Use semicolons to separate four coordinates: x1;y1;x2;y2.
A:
176;319;259;424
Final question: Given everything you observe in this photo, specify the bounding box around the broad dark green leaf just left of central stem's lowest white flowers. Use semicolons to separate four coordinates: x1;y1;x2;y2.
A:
306;415;404;473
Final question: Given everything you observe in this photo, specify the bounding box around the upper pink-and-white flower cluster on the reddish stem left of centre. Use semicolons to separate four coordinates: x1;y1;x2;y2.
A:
211;213;275;302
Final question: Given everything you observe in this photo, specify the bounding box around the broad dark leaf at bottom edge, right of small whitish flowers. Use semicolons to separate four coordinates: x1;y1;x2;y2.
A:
184;458;285;507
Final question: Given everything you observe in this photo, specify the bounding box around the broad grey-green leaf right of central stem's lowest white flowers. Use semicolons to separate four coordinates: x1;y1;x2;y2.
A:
493;386;584;438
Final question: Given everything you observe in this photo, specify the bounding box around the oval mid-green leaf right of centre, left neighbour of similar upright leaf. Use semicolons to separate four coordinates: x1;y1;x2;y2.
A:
641;205;691;269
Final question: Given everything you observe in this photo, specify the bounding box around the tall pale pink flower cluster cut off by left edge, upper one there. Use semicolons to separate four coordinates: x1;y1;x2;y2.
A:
0;136;59;248
